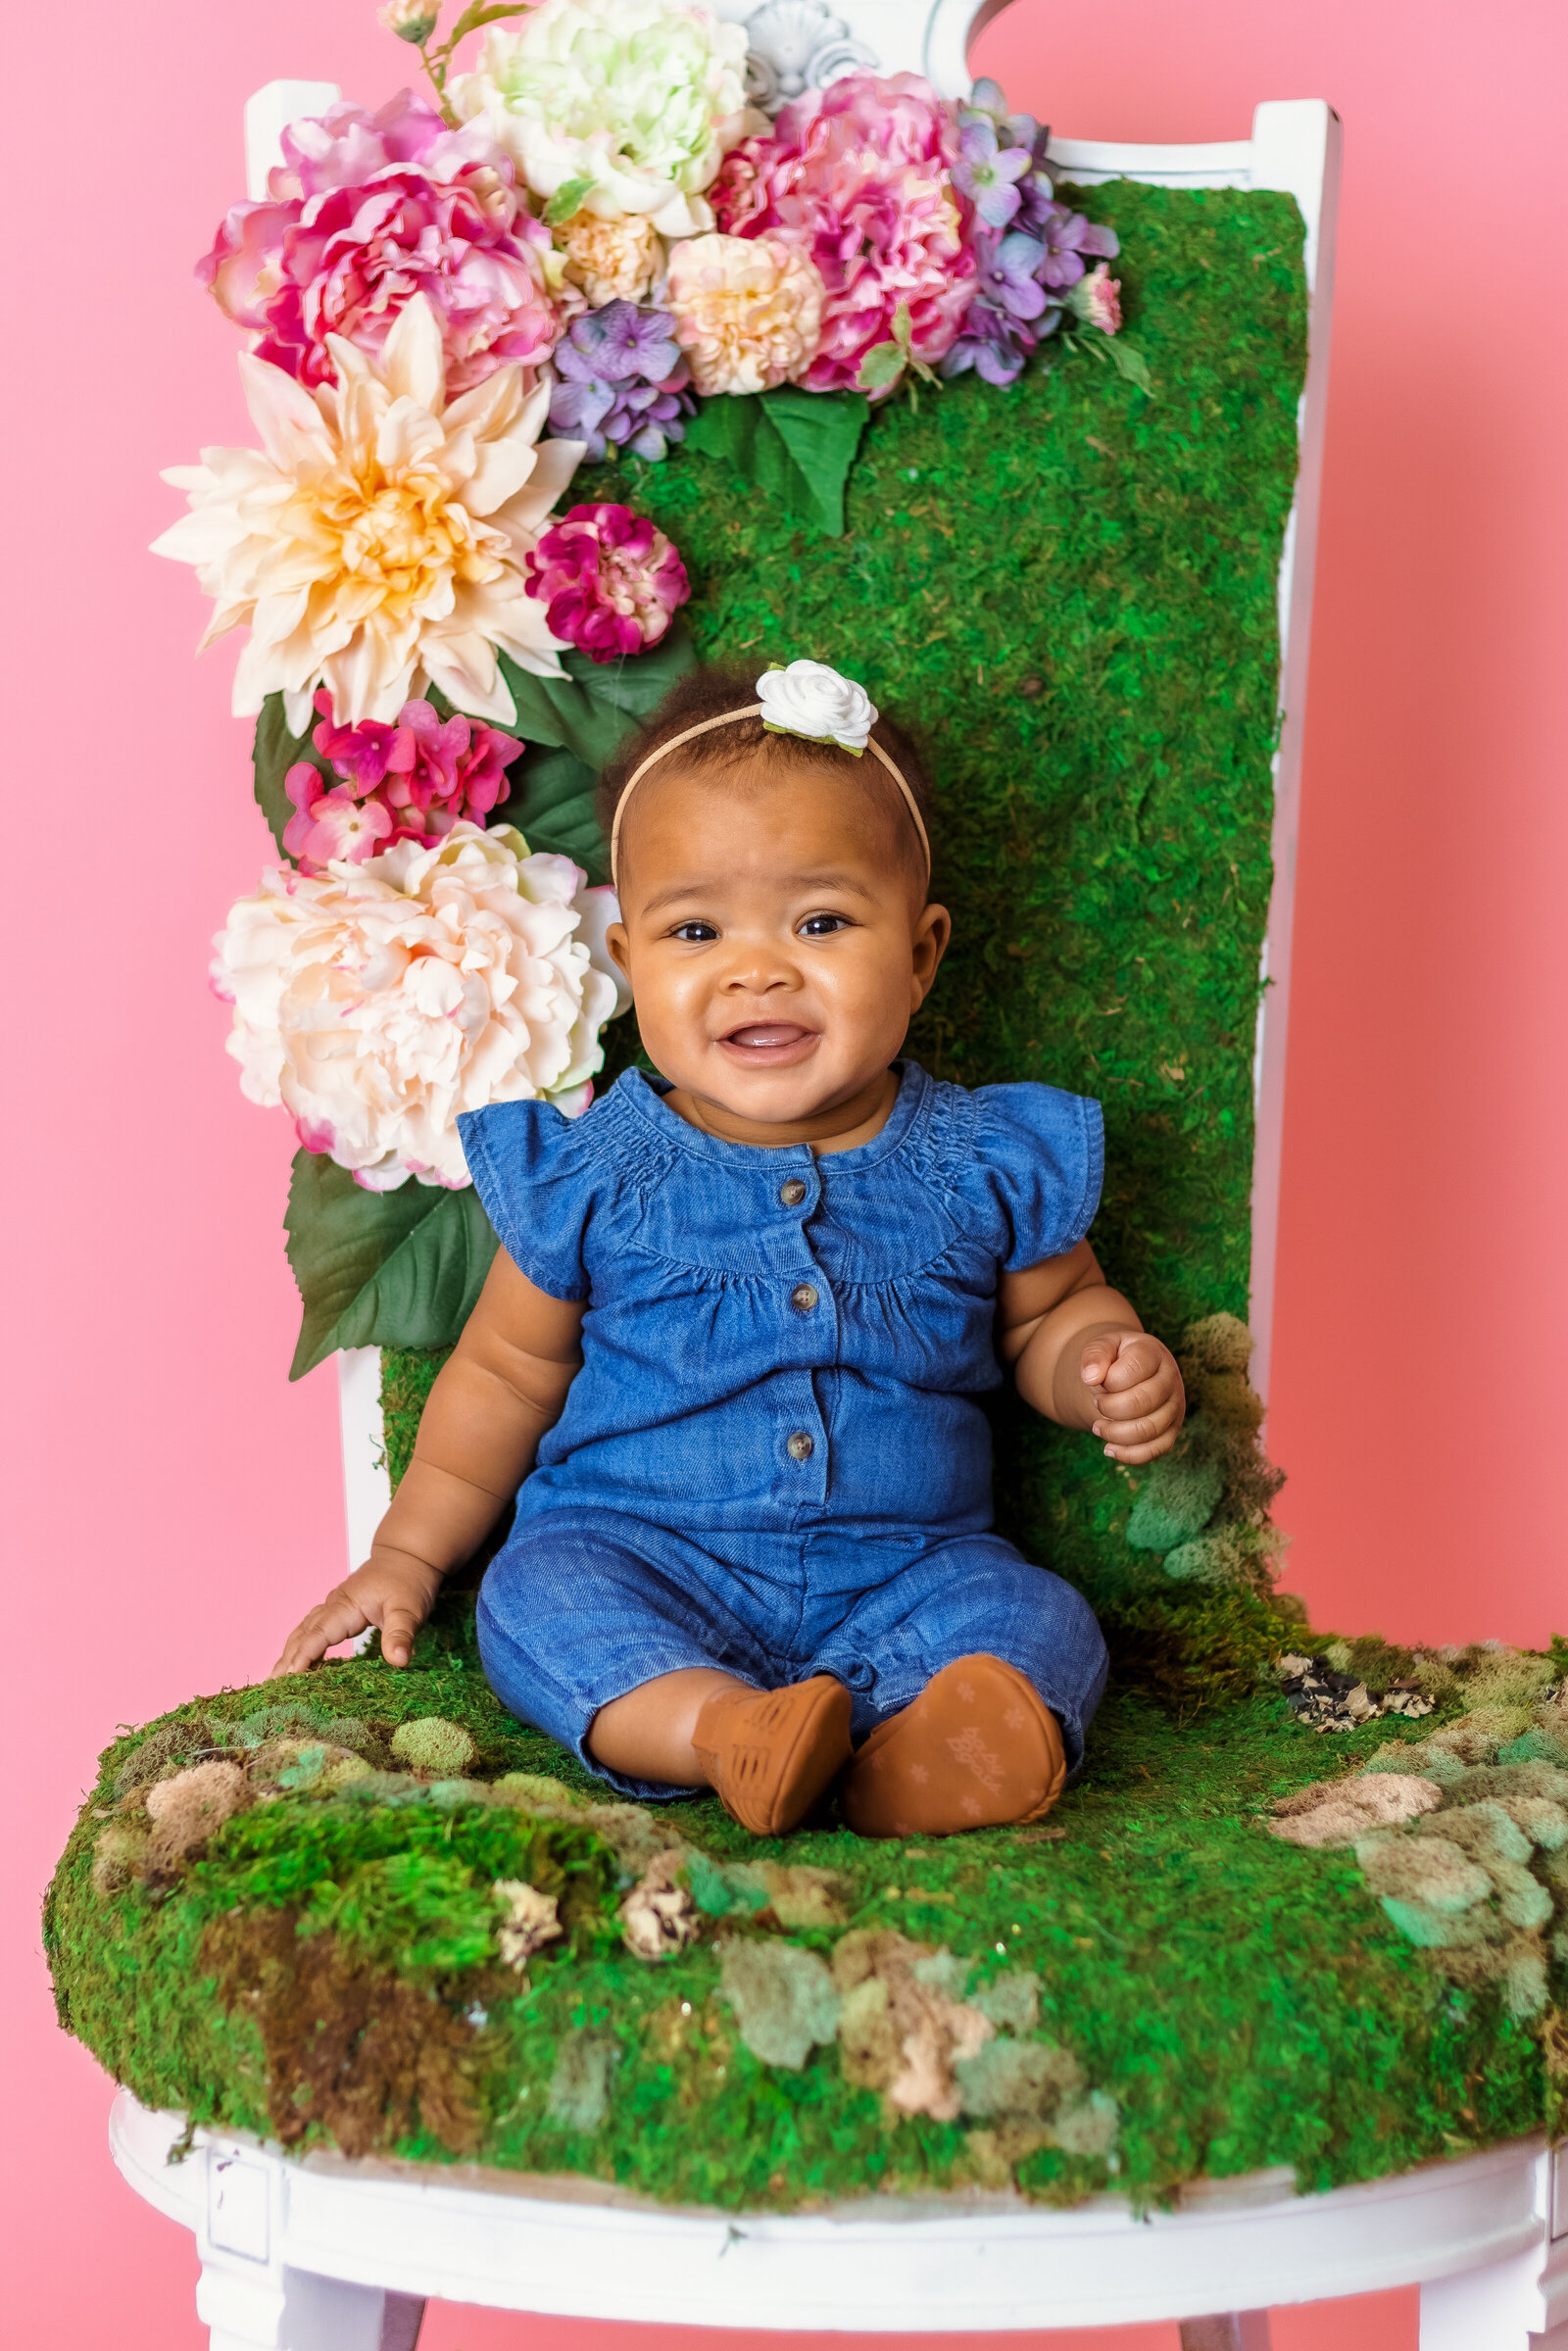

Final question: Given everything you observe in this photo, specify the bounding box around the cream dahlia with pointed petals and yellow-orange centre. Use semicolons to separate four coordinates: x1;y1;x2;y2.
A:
153;294;583;733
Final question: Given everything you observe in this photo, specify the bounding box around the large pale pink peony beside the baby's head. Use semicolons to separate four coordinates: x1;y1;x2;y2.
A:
212;820;620;1192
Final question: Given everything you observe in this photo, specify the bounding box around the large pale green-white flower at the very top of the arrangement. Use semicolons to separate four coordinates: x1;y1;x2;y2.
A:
449;0;757;237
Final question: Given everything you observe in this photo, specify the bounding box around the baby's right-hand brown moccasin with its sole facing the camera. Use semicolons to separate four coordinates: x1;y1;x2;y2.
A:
839;1655;1067;1837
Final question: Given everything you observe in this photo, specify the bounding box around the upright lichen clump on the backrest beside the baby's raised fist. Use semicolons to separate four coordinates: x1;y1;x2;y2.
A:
1126;1314;1284;1598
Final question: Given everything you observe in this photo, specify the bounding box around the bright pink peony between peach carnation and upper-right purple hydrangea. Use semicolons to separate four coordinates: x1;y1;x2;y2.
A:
710;73;976;393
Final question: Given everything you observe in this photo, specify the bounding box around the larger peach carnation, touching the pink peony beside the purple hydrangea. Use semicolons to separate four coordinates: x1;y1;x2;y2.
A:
665;235;823;393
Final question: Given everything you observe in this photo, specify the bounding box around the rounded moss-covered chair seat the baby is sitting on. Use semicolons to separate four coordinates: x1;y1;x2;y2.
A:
49;1596;1568;2210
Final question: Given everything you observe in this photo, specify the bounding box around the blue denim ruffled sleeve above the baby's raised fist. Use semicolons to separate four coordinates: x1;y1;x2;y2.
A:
976;1084;1104;1274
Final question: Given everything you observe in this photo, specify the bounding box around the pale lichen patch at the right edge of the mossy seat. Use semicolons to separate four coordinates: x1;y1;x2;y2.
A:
1269;1648;1568;2017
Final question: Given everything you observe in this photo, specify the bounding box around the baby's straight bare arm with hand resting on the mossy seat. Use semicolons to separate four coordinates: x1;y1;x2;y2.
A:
272;1250;583;1674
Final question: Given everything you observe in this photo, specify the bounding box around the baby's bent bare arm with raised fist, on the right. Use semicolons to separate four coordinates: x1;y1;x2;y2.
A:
997;1242;1187;1465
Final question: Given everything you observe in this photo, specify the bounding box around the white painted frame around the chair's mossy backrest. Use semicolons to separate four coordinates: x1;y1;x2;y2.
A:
244;18;1340;1561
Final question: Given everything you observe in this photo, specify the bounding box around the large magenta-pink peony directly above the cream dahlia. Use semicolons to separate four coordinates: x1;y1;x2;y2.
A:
195;89;560;395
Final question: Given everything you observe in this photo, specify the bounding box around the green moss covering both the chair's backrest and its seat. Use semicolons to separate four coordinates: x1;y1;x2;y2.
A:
47;133;1568;2341
